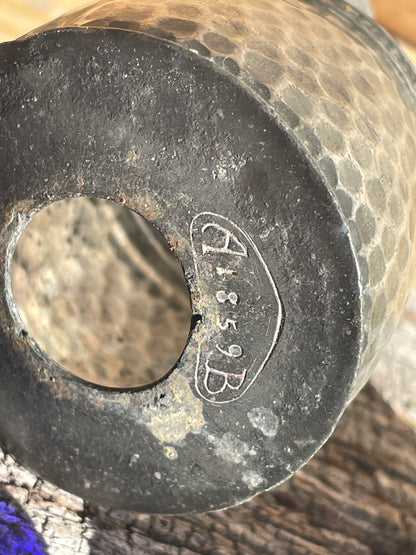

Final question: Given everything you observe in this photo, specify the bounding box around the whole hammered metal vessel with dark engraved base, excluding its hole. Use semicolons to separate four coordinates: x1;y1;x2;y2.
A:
0;0;416;513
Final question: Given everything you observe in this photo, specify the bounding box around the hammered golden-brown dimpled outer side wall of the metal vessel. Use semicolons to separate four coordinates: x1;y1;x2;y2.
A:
30;0;416;400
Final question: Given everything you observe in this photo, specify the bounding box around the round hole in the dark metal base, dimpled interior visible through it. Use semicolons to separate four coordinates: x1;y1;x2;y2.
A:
12;198;192;387
